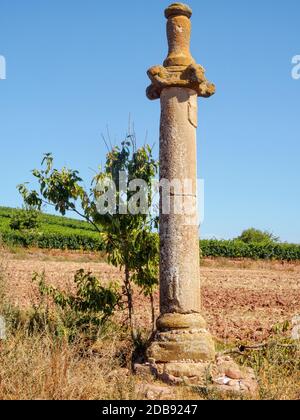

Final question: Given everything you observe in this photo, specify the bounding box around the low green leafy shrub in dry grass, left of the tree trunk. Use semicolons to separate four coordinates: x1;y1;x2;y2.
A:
28;270;122;341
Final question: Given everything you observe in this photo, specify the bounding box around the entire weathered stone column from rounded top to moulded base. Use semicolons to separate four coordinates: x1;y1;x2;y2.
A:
147;3;215;364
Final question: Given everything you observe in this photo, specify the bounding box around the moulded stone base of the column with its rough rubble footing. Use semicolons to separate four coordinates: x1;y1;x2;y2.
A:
141;313;258;396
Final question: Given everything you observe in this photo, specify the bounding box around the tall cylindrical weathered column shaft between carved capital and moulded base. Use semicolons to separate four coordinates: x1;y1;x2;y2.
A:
160;88;201;314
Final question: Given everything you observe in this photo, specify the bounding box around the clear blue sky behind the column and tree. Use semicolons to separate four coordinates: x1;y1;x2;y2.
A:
0;0;300;243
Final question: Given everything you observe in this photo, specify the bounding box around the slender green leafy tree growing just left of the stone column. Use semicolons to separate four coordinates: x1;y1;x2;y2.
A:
18;135;159;338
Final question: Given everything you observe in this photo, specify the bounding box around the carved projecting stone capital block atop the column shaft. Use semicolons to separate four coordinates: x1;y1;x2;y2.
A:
147;64;216;100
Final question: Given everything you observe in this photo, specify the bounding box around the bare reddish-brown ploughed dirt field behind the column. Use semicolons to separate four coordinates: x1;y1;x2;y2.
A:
0;250;300;343
